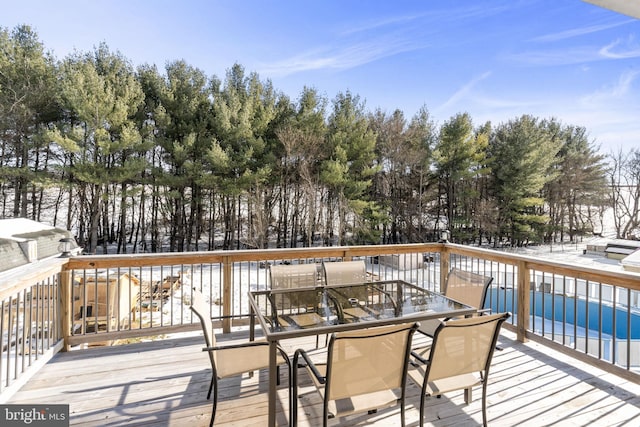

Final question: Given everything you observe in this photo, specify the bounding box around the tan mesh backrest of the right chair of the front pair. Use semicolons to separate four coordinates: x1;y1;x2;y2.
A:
426;313;509;381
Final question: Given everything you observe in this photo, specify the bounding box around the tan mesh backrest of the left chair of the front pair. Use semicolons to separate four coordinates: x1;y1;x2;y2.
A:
325;323;418;401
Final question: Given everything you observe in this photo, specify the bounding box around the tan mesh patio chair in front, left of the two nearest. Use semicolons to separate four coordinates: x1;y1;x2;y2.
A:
291;323;418;426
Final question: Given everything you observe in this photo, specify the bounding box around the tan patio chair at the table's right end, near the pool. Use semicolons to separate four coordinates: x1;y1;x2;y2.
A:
419;268;493;337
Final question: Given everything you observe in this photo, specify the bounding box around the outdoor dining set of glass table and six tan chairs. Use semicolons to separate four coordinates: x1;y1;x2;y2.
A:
191;260;509;427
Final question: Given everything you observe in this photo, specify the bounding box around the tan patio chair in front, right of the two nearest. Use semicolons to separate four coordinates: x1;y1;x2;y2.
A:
408;313;509;426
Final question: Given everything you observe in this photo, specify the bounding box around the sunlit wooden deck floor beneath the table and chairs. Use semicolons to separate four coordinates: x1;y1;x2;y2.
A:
7;331;640;427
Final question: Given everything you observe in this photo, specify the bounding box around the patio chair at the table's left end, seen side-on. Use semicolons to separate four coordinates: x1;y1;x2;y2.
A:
190;290;291;426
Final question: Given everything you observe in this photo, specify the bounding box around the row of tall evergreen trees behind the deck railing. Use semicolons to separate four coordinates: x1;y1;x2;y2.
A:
0;25;640;253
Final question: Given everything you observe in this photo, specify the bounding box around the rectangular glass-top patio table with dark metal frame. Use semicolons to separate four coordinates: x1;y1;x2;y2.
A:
249;280;477;427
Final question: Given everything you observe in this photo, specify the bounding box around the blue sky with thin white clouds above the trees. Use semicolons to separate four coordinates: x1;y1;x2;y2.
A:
0;0;640;154
